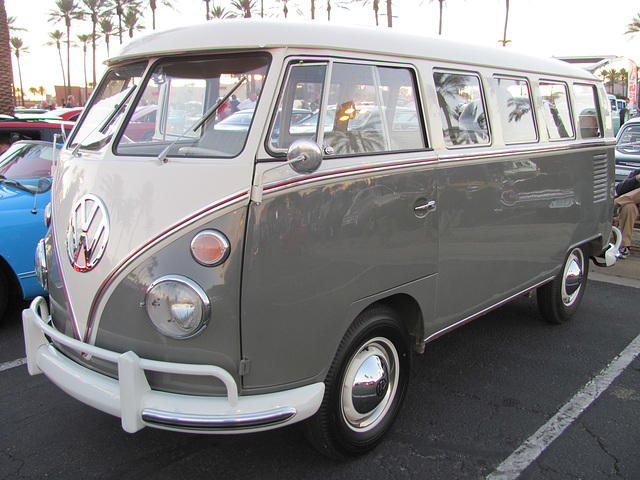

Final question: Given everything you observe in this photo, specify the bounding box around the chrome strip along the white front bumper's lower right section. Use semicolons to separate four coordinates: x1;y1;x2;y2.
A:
142;407;298;431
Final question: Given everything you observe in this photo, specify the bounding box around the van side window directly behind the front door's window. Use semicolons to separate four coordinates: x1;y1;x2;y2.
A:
433;72;490;147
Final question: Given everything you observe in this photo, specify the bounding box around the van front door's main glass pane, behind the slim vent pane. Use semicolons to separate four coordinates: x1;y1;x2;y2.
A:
324;63;425;154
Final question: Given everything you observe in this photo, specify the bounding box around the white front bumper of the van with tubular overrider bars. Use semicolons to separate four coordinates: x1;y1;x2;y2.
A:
22;297;324;433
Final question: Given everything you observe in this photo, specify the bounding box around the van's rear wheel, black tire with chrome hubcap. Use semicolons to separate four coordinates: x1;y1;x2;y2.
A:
537;247;589;323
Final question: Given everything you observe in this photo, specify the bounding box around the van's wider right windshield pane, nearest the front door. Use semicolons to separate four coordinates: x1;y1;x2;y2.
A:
116;55;268;159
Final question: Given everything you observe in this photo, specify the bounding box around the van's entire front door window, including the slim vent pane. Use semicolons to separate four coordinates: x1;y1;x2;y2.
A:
270;62;425;155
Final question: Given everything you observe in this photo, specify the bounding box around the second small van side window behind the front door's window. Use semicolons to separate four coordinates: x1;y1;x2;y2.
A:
493;77;538;144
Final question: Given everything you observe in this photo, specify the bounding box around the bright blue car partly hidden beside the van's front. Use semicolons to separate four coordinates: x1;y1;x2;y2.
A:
0;140;54;318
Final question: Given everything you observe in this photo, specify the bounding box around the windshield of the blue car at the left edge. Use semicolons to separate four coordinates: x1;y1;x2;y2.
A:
0;142;53;180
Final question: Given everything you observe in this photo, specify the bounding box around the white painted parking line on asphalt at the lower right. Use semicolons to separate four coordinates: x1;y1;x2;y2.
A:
487;335;640;480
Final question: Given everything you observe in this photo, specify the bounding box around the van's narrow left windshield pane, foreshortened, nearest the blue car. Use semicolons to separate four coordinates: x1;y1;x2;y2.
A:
70;63;146;150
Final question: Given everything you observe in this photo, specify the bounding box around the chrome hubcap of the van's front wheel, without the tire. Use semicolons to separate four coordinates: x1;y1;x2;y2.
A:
341;337;400;432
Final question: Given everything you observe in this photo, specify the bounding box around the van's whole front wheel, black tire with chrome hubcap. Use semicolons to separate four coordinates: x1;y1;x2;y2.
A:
303;307;411;459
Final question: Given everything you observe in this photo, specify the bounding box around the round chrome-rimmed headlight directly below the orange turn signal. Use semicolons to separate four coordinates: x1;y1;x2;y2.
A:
145;275;211;339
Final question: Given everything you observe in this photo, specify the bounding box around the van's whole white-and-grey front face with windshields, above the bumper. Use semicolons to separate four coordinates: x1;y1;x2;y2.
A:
45;55;268;394
